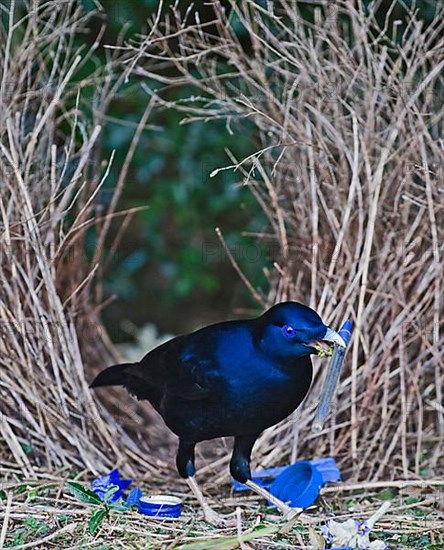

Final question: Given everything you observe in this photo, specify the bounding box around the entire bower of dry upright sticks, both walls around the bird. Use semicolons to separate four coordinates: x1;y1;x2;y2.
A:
0;0;444;548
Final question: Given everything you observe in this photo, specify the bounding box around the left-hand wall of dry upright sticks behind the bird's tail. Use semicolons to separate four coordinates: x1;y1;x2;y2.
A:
0;1;160;476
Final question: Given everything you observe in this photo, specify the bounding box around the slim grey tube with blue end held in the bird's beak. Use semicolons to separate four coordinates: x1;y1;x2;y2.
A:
312;321;352;432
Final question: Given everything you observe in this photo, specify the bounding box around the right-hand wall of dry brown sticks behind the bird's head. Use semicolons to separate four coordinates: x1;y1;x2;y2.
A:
127;1;444;480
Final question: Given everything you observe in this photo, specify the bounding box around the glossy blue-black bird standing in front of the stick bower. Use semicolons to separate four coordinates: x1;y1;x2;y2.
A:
91;302;345;523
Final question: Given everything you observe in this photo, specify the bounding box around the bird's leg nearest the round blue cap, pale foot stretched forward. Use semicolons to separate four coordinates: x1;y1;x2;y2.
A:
230;433;301;519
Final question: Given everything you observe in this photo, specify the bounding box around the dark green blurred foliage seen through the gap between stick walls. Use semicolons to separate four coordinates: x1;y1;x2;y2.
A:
76;0;434;342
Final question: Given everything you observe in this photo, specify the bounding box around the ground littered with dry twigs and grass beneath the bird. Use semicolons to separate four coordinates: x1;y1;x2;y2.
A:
0;472;444;550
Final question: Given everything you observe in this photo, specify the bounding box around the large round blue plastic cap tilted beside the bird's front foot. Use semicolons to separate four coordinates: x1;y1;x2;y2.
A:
270;461;323;508
